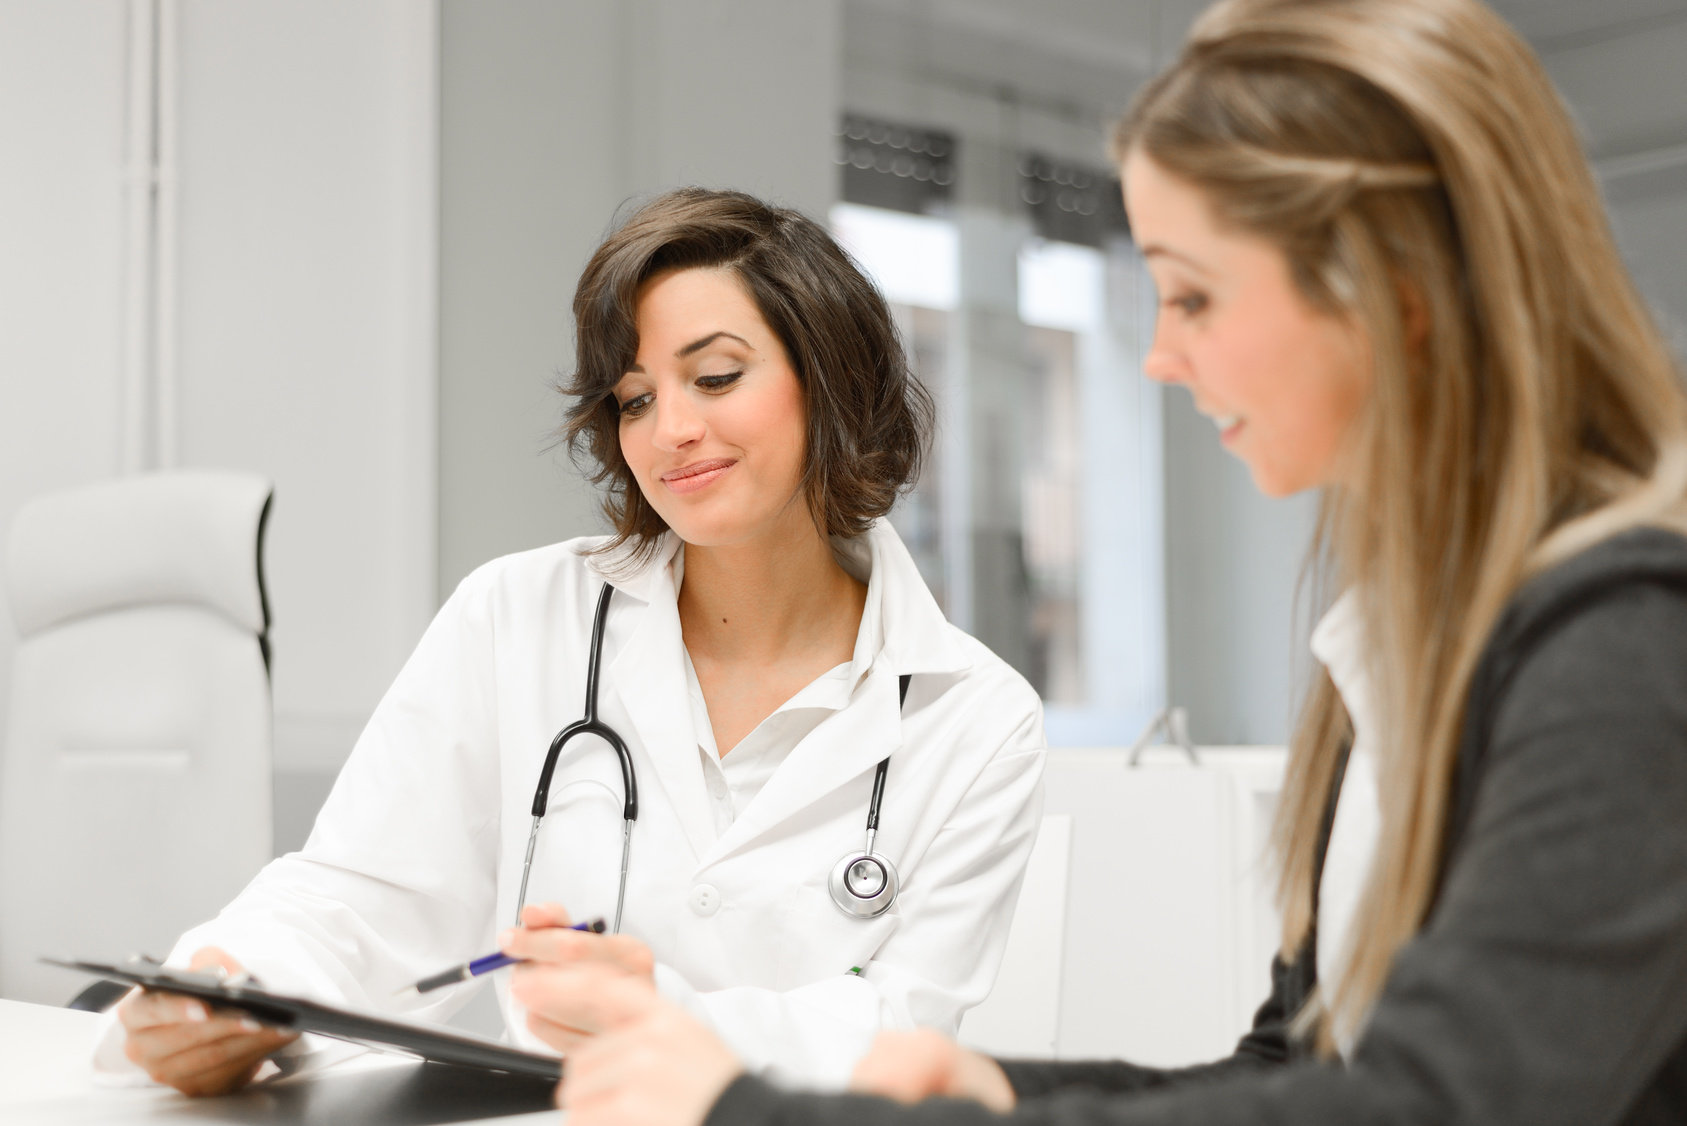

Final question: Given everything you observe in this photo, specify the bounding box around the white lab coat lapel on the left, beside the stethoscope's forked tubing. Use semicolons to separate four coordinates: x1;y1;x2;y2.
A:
607;544;715;856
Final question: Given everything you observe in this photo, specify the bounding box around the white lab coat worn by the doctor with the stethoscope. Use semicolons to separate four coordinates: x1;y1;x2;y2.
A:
101;522;1044;1085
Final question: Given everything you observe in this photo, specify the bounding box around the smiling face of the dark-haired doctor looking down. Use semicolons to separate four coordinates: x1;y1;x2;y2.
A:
614;268;815;547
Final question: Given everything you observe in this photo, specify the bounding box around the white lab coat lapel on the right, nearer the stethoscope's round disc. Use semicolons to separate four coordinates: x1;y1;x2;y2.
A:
703;662;903;863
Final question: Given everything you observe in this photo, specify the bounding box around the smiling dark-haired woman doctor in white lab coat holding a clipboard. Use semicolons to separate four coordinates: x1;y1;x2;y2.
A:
100;191;1044;1094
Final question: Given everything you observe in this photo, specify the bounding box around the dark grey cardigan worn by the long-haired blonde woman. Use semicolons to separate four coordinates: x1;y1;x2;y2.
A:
707;528;1687;1126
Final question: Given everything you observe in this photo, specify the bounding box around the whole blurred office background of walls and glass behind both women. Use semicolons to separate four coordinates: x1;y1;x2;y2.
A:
0;0;1687;1039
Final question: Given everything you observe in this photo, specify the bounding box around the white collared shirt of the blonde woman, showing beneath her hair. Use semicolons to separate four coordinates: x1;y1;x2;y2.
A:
1312;589;1382;1058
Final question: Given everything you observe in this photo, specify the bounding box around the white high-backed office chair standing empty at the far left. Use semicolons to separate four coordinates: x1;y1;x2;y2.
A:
0;471;273;1004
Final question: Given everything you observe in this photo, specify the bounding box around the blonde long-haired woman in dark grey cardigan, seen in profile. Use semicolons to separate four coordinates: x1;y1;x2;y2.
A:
516;0;1687;1126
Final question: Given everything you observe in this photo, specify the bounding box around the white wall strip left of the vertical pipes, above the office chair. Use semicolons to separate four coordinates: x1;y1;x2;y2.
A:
0;0;127;776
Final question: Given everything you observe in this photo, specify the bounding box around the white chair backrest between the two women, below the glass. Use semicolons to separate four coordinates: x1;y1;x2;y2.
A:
960;746;1287;1067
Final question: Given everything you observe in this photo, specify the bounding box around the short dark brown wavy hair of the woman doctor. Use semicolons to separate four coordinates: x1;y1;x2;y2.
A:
563;187;935;555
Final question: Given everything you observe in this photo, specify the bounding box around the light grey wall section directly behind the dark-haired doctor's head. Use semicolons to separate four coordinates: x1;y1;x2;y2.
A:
439;0;838;596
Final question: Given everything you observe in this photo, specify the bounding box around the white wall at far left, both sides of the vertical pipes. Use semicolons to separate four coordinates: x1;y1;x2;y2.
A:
0;0;437;813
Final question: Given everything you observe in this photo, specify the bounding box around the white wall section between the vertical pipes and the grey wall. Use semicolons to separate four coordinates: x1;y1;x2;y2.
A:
167;0;437;768
